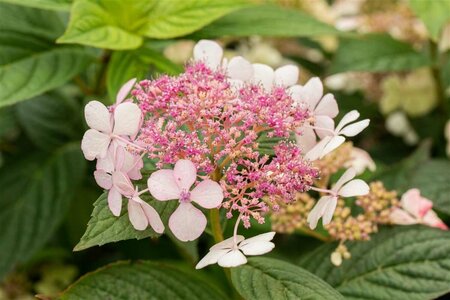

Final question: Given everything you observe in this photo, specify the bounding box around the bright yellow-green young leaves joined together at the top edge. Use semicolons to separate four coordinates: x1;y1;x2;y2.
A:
58;0;245;50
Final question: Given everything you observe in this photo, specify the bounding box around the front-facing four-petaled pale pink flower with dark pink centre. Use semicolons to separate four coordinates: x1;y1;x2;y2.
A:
147;159;223;242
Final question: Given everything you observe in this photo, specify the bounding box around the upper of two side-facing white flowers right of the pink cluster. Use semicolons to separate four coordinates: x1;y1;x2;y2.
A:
305;110;370;161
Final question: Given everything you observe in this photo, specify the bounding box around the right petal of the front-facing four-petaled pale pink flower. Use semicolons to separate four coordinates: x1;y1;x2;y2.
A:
191;179;223;208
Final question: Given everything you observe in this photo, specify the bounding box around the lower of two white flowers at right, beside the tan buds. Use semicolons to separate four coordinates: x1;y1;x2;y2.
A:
307;168;369;229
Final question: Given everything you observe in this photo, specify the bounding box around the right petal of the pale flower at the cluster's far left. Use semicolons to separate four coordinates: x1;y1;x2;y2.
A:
113;102;142;136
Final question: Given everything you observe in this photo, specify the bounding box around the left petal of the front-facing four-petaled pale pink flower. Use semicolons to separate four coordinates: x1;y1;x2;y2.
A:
147;170;181;201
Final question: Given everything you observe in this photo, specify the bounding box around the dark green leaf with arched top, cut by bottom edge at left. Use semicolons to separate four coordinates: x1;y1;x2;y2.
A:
60;261;227;300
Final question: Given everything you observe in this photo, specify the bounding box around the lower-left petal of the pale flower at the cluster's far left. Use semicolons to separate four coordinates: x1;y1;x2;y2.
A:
81;129;111;160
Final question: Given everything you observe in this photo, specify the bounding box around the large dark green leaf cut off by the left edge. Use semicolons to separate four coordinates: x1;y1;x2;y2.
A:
0;143;86;277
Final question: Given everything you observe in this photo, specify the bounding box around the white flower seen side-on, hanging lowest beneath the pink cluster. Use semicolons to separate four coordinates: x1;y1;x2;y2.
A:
195;232;275;269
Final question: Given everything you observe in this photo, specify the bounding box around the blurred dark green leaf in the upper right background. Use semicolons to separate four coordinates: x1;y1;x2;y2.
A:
330;34;431;73
